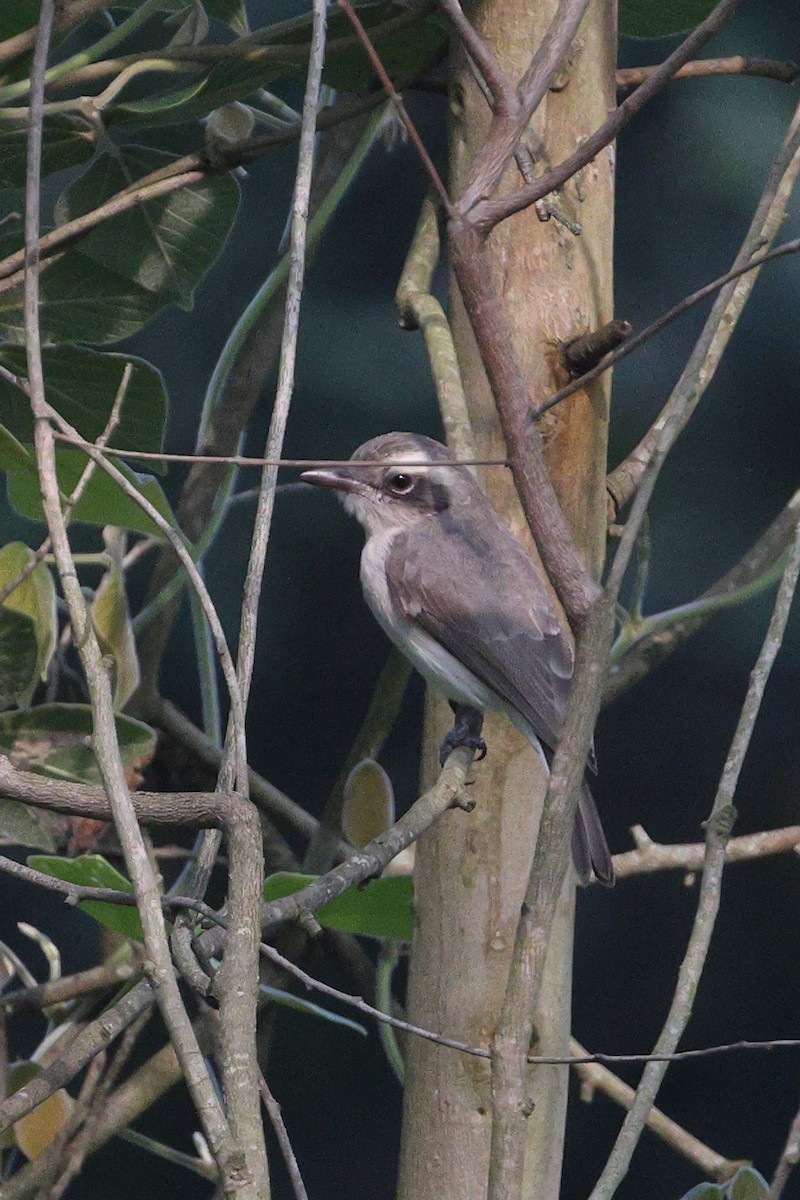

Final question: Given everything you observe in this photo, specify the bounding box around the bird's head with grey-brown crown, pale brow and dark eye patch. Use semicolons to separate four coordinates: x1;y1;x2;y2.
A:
300;433;476;533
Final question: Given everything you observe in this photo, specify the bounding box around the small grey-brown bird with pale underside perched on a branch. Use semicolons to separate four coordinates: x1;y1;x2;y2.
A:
300;432;614;887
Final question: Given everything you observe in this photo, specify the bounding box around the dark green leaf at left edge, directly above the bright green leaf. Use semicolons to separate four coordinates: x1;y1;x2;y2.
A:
0;344;167;474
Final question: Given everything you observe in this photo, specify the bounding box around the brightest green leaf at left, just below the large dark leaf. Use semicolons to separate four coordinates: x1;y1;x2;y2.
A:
8;448;175;538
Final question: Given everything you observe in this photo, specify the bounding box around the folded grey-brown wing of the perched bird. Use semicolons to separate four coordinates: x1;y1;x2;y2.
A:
386;505;573;748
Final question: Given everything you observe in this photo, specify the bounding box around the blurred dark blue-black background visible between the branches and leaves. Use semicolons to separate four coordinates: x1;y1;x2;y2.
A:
4;0;800;1200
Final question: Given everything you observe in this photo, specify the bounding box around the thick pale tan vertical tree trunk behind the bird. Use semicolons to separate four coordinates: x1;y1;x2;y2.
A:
399;0;616;1200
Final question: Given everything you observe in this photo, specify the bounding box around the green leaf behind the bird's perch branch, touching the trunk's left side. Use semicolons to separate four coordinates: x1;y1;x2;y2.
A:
264;871;414;942
